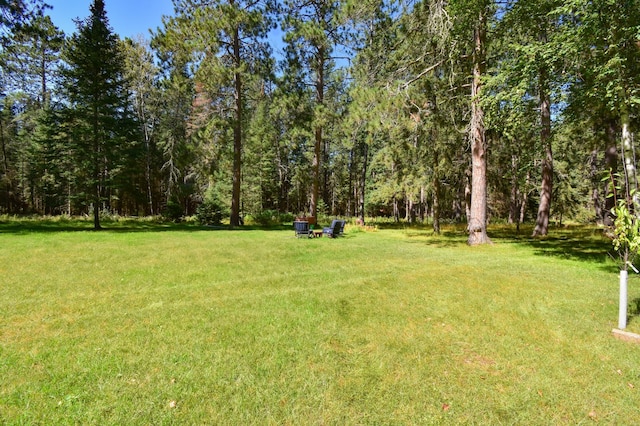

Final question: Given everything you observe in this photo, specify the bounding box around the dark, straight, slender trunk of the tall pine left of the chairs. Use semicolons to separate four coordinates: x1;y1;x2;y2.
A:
230;27;242;227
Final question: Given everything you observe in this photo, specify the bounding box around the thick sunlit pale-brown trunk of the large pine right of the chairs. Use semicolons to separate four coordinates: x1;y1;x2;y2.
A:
467;10;491;245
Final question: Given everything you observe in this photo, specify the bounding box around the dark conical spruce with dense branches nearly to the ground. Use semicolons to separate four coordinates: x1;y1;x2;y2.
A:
63;0;135;229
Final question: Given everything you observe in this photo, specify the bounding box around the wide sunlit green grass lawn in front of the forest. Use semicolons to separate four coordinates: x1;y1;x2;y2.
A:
0;221;640;425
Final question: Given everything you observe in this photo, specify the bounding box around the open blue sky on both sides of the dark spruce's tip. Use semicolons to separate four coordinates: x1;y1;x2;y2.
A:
45;0;173;38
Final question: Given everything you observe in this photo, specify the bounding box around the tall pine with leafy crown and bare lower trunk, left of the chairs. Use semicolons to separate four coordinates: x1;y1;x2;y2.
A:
166;0;274;226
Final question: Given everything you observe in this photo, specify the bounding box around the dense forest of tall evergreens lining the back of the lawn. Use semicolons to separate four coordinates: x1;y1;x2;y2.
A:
0;0;640;244
